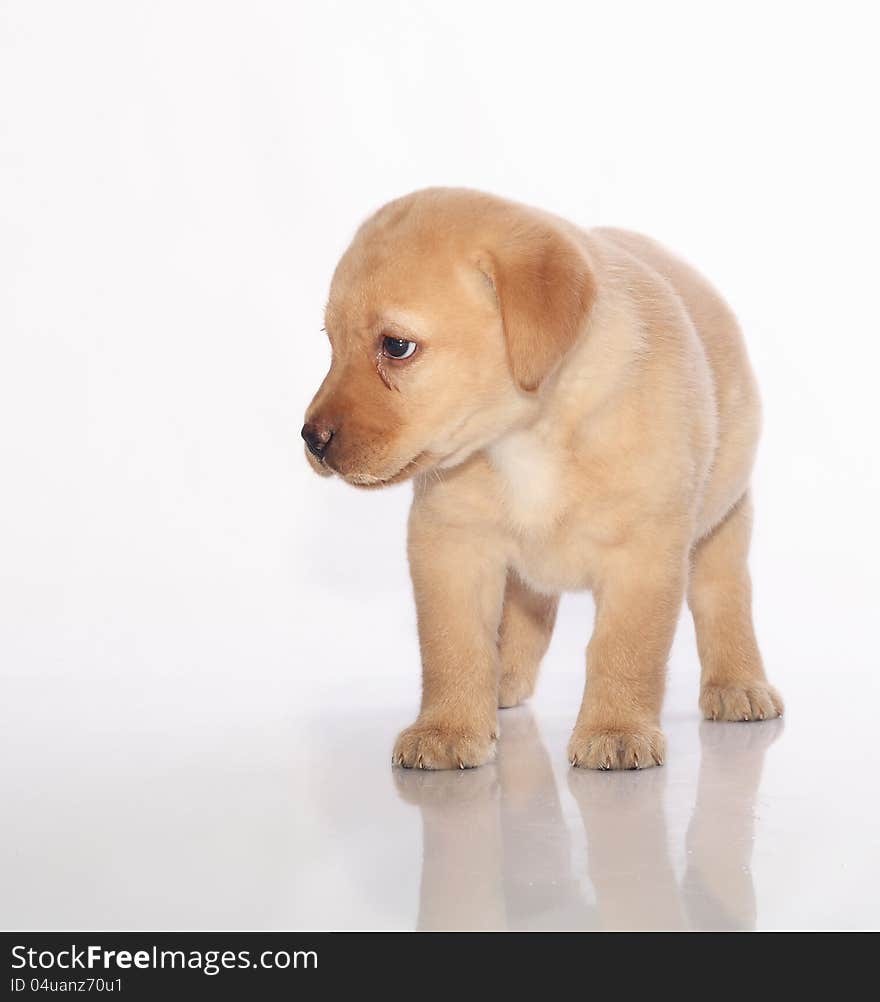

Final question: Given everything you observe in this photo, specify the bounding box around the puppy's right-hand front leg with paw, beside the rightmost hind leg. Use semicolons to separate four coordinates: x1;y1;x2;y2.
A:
568;542;687;769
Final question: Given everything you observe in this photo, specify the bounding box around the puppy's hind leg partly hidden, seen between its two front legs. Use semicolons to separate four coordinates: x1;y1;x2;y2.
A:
498;571;559;706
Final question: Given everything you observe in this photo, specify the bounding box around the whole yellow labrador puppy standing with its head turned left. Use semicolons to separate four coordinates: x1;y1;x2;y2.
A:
303;188;783;769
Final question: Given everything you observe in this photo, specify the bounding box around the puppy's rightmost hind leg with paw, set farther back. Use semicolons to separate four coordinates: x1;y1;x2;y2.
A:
688;492;783;720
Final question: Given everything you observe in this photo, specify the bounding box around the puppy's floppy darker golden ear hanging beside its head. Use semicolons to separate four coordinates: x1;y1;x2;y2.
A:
479;224;595;391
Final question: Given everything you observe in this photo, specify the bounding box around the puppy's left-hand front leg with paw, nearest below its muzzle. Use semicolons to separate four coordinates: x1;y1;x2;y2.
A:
392;508;506;769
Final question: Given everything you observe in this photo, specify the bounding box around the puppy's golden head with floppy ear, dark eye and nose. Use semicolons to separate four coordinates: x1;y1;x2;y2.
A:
303;188;594;487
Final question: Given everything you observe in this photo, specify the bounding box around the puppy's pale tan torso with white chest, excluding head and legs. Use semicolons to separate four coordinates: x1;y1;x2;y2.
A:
441;230;760;593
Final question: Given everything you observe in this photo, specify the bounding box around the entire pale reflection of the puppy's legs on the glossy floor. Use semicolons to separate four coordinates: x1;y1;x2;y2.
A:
395;707;782;931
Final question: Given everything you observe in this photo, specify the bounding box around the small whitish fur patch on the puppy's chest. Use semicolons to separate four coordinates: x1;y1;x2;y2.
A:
487;431;559;530
